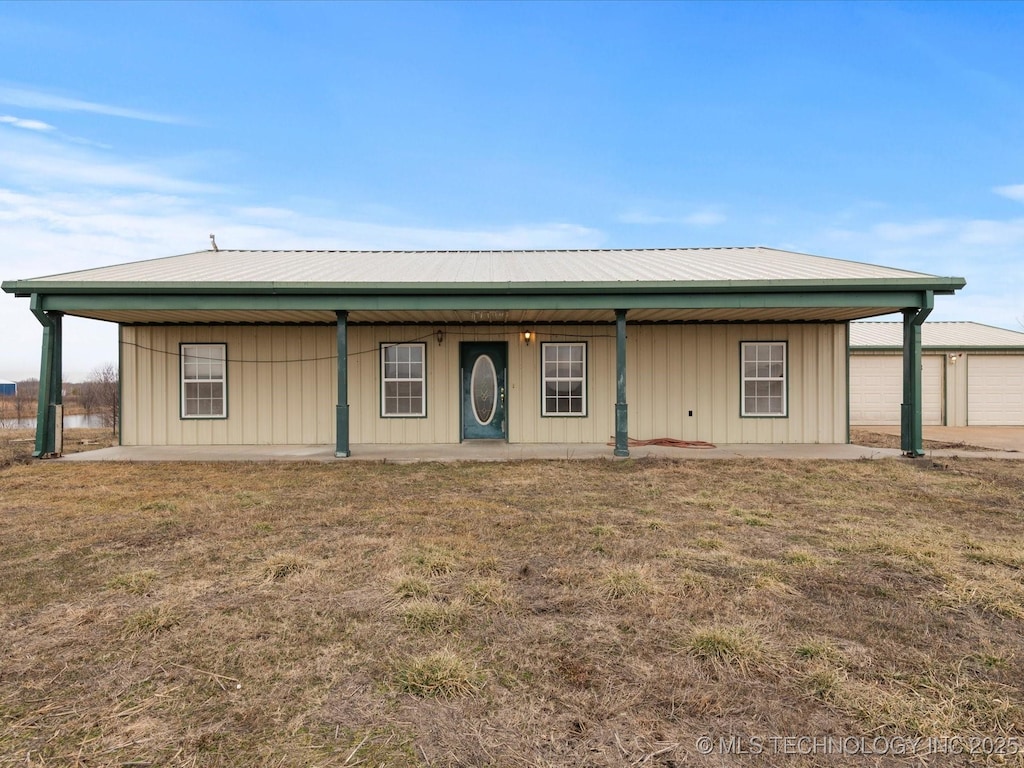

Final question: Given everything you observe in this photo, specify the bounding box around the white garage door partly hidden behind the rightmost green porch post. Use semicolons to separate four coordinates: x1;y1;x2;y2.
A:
850;354;943;425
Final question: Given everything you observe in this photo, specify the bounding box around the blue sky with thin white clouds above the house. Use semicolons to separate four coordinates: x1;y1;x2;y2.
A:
0;2;1024;381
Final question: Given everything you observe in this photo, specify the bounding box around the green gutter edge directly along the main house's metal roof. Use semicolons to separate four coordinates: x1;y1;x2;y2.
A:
2;275;967;297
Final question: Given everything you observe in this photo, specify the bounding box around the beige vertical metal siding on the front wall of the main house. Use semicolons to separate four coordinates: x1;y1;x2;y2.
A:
122;324;846;445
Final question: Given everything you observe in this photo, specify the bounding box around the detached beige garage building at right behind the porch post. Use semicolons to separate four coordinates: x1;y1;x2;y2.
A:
850;323;1024;427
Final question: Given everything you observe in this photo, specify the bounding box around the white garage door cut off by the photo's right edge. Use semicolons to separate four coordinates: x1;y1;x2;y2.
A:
967;354;1024;426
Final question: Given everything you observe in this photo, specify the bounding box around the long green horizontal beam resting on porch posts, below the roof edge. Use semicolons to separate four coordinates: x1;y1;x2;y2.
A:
24;289;927;312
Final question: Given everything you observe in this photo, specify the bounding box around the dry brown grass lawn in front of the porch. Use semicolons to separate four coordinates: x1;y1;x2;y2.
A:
0;430;1024;768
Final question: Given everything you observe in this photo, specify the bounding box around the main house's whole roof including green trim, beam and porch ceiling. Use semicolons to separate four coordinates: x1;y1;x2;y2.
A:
3;247;965;324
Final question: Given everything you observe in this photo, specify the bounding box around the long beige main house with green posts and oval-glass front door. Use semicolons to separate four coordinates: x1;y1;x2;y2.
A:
3;248;965;457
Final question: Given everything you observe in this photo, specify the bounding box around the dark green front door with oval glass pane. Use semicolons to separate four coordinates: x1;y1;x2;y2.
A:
459;341;508;440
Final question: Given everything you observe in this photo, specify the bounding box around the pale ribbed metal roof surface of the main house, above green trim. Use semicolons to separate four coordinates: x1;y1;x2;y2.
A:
18;247;931;285
